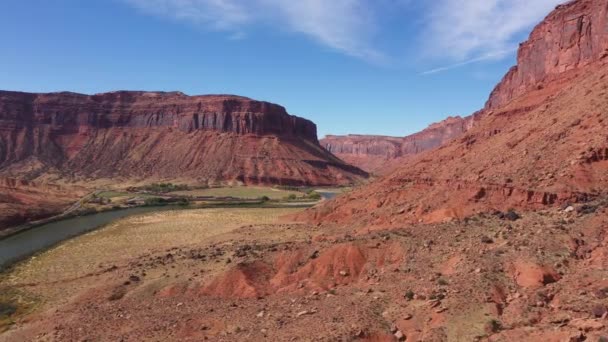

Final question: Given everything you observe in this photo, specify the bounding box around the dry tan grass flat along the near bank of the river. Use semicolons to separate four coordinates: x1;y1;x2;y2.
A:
0;208;301;333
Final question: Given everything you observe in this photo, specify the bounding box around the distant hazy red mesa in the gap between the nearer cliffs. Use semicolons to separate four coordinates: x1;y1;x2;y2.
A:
321;116;474;174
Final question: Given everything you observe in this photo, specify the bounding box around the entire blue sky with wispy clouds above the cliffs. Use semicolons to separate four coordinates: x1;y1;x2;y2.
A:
0;0;561;136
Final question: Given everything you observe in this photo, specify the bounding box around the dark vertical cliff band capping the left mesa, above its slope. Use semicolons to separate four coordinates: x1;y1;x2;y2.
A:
0;91;317;142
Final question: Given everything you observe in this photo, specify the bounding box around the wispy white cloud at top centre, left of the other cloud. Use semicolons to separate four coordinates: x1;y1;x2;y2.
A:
124;0;383;61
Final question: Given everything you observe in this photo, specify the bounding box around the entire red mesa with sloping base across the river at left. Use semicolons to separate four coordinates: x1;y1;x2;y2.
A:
0;92;365;185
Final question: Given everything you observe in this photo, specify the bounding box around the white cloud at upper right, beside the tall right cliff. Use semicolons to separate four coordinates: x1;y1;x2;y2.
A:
424;0;564;65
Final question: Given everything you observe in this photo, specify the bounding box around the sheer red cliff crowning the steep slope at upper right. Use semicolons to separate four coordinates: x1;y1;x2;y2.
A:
486;0;608;109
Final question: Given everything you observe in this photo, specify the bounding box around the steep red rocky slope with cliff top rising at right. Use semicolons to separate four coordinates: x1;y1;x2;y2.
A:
305;0;608;227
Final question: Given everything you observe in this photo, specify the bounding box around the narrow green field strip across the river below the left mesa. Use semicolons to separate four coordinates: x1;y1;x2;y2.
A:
171;186;304;199
